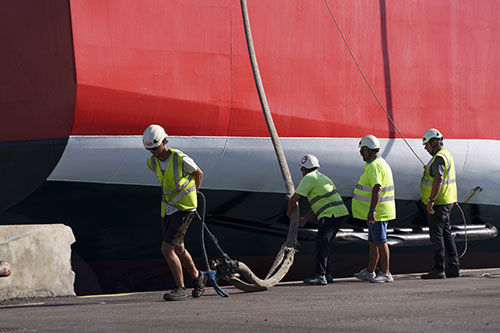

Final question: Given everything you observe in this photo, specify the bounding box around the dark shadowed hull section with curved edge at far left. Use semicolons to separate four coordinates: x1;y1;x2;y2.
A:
0;0;76;212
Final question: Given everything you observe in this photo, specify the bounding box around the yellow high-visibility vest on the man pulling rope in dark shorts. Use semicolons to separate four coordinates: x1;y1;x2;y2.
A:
148;148;198;217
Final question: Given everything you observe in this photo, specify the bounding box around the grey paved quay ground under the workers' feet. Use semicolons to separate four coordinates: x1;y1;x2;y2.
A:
0;268;500;332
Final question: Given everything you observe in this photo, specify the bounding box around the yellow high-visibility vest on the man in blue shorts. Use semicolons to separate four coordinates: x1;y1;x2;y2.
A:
352;157;396;221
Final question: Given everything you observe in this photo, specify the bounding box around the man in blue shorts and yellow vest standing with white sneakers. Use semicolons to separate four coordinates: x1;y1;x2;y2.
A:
352;135;396;282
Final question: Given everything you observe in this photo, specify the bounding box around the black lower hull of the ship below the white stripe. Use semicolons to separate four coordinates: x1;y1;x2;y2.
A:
0;182;500;295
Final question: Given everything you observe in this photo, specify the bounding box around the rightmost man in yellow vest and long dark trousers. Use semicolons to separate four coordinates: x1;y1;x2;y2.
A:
420;128;460;279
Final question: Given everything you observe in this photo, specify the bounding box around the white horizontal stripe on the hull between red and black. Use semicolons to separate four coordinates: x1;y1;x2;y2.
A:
49;136;500;205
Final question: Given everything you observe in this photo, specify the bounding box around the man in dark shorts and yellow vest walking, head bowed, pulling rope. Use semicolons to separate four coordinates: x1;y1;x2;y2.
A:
142;125;207;301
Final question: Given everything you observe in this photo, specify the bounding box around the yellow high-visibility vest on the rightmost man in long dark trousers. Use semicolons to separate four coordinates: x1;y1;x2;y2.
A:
420;148;457;205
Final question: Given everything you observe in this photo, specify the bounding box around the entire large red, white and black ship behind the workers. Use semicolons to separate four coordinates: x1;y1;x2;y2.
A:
0;0;500;294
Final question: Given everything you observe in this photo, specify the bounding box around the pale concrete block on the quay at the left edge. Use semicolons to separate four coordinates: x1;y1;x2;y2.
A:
0;224;75;300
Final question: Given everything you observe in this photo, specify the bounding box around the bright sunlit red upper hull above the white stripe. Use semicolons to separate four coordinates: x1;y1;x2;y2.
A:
67;0;500;140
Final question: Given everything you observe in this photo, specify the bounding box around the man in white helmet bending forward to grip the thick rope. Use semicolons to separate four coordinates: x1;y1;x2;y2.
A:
287;154;349;285
